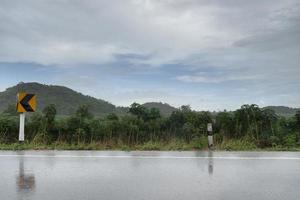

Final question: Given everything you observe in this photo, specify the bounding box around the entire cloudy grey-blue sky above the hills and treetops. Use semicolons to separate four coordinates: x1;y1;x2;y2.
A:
0;0;300;110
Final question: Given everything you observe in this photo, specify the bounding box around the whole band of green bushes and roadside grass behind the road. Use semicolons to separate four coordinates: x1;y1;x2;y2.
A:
0;103;300;150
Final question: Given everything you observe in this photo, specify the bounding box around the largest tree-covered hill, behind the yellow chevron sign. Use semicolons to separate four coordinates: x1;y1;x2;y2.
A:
0;83;116;116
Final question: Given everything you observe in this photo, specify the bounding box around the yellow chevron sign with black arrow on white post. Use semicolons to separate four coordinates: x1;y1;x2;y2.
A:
17;92;36;142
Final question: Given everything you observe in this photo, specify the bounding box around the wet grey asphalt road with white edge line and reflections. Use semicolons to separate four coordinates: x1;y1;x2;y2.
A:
0;151;300;200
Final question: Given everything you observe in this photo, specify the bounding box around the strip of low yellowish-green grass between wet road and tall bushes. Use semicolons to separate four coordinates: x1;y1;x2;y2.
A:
0;137;300;151
